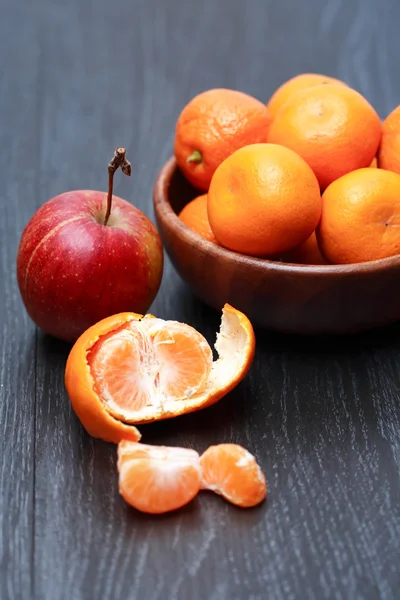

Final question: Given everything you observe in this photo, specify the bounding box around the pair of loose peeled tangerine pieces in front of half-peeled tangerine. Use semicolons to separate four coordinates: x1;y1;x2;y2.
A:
118;440;267;514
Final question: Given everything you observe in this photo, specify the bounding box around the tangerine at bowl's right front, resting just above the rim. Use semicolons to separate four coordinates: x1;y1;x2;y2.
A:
317;168;400;264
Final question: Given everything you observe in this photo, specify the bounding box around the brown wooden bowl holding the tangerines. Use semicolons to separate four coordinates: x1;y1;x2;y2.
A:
153;158;400;334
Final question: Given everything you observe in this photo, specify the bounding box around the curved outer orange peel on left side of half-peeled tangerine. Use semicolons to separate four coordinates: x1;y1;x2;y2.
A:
65;313;146;443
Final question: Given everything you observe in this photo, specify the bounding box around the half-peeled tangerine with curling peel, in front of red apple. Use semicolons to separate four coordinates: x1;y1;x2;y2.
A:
65;304;255;443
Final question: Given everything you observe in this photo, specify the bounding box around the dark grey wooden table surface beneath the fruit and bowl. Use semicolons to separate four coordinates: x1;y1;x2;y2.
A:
0;0;400;600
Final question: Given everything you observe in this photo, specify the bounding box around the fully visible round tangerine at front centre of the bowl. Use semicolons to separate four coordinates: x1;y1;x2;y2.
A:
207;144;321;256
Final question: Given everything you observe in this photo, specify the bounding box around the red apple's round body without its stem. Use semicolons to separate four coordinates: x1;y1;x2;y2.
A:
17;190;163;342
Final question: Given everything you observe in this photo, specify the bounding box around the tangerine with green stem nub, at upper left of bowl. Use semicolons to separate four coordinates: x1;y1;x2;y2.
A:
174;89;271;191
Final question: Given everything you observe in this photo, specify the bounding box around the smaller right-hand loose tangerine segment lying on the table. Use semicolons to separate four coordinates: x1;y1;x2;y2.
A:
200;444;267;508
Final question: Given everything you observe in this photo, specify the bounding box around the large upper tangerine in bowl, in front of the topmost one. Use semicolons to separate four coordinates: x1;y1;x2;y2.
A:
268;84;382;189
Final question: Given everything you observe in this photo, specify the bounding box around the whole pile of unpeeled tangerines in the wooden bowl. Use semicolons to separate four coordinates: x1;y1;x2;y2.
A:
175;74;400;264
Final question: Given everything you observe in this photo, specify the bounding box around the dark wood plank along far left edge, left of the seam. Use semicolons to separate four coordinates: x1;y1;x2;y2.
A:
0;4;41;599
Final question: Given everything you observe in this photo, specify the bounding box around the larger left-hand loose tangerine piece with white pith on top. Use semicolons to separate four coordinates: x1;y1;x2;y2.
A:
117;440;201;514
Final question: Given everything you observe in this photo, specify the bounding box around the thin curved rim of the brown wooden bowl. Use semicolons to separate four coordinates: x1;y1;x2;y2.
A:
153;156;400;276
